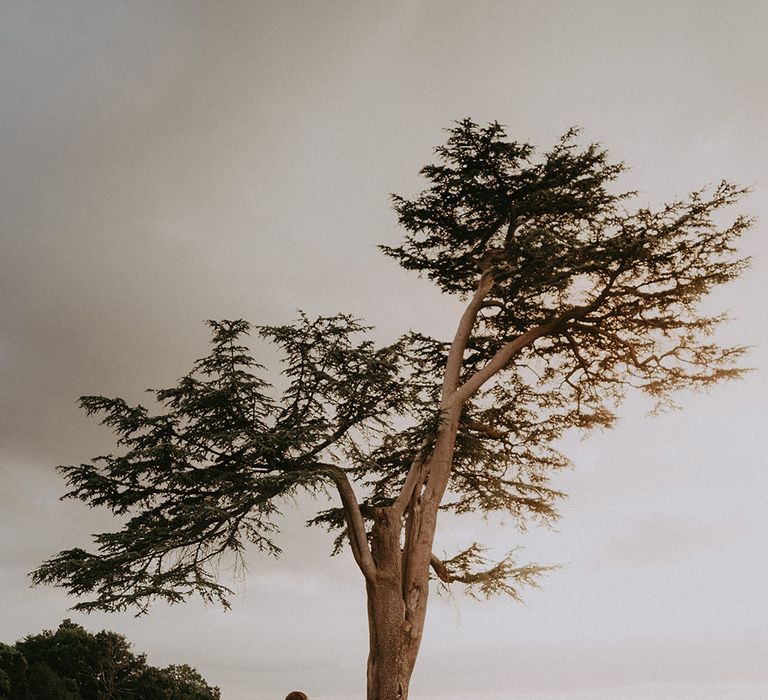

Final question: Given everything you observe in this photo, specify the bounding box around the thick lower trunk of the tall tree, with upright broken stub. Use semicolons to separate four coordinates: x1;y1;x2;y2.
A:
366;508;429;700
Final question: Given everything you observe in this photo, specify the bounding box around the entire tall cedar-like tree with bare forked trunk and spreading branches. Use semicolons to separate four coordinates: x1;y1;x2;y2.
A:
33;120;751;700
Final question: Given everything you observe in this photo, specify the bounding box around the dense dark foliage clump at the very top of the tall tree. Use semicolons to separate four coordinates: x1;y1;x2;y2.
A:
382;119;628;296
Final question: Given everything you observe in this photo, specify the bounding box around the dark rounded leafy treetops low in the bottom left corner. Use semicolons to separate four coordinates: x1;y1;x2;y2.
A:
0;620;220;700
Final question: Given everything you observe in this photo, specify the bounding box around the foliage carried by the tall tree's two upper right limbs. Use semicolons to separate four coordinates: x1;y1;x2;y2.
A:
383;120;751;396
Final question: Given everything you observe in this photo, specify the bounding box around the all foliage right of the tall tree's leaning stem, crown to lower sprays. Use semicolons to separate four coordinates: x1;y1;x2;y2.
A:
382;120;751;523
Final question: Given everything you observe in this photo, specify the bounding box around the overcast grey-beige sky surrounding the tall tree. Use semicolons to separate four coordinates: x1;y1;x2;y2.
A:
0;0;768;700
